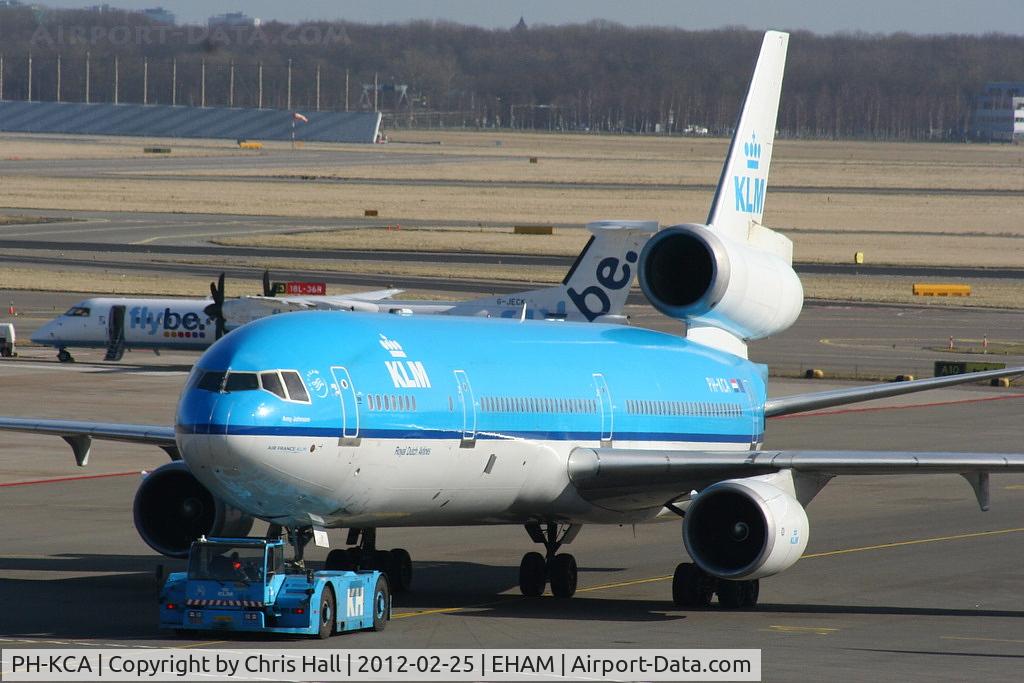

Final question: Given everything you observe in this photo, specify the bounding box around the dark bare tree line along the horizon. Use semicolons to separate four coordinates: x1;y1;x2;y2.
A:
0;7;1024;140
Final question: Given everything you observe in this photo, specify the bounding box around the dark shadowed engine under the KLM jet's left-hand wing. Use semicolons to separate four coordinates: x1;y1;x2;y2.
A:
132;461;253;557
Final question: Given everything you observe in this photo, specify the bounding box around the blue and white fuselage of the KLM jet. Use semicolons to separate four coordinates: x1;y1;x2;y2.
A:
176;311;765;527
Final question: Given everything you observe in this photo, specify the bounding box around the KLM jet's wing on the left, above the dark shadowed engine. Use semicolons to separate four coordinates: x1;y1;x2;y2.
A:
0;418;181;467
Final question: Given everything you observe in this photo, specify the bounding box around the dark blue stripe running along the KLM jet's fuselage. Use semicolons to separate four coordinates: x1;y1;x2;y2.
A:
174;423;761;443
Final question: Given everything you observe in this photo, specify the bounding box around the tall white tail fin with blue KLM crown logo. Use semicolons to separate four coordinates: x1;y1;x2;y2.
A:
708;31;793;263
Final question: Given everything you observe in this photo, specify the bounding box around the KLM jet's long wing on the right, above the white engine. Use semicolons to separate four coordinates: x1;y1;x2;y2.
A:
568;449;1024;511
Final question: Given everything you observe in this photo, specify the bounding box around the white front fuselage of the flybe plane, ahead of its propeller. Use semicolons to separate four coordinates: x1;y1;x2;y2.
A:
32;297;214;350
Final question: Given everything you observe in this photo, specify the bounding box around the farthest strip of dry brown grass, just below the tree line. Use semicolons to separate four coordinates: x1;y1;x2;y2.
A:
134;132;1024;190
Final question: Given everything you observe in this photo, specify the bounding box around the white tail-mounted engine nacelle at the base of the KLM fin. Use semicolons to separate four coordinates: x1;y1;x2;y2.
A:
638;223;804;340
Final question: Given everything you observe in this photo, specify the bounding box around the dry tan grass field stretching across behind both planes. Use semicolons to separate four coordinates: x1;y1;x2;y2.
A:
0;131;1024;305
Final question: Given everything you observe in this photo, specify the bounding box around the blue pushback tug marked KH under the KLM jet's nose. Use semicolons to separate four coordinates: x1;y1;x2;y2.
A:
160;537;391;638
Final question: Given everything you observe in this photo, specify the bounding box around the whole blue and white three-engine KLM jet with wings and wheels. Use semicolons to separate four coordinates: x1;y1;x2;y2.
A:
0;32;1024;608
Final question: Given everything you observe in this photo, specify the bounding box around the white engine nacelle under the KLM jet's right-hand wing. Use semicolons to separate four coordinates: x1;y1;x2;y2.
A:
683;478;809;580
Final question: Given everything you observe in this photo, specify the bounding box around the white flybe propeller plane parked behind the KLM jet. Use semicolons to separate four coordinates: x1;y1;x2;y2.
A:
32;221;657;362
